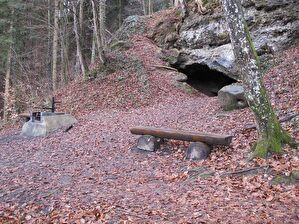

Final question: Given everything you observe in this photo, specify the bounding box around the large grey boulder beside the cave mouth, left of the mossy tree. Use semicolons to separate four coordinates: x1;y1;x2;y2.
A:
218;83;248;110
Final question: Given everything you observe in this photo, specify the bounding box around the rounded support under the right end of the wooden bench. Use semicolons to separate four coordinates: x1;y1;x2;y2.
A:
186;142;212;160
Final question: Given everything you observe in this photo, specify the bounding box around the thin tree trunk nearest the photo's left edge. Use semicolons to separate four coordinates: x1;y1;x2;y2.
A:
3;22;13;123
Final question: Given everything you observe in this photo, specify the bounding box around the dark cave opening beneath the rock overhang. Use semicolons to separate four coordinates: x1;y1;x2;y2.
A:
177;63;237;97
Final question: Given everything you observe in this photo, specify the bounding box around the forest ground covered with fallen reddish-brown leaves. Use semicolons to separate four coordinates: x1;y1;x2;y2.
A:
0;24;299;223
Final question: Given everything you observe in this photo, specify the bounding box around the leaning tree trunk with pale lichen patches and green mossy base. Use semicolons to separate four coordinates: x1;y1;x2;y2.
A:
222;0;291;157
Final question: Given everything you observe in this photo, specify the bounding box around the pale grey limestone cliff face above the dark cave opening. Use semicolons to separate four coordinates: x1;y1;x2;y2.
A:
153;0;299;78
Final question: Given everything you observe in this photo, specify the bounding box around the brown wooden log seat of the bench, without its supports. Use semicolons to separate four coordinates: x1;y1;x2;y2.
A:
130;126;232;145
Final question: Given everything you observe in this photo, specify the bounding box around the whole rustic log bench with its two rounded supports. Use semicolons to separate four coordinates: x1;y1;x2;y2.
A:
130;127;232;159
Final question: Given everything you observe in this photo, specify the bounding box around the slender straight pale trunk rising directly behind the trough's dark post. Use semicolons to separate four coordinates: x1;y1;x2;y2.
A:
52;0;59;91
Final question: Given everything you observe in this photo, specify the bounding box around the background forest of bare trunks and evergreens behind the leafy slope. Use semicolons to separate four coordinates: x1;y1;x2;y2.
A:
0;0;172;122
